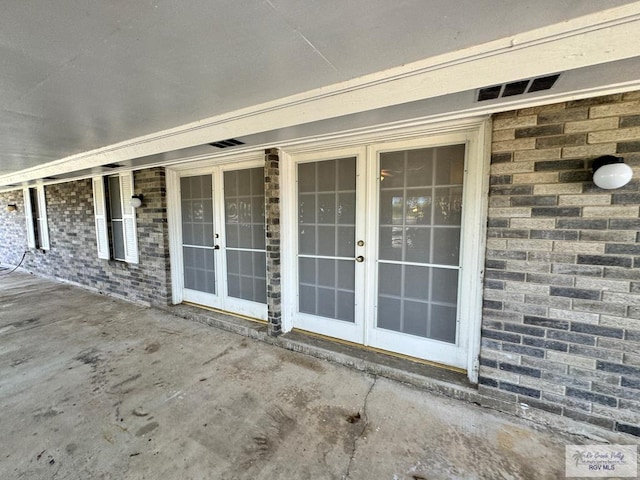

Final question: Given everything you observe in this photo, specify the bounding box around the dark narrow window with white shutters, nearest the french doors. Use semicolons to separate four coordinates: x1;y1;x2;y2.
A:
93;172;138;263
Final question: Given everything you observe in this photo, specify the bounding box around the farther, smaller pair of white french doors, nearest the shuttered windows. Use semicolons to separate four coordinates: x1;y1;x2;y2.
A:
178;164;267;319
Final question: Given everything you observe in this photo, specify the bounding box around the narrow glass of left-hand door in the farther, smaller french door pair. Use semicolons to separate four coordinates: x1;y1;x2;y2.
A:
180;175;216;294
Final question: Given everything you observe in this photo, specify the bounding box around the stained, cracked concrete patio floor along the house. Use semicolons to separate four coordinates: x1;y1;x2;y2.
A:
0;272;629;480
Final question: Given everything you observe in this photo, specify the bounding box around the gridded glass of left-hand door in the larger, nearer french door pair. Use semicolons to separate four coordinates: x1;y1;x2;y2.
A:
298;158;356;322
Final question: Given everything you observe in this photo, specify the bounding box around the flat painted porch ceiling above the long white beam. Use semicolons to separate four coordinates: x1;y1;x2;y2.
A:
0;0;640;184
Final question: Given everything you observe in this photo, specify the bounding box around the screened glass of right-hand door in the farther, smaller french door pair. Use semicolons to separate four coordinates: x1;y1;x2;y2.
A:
224;167;267;303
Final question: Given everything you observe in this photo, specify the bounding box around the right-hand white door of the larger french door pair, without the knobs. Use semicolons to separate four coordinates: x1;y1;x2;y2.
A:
367;139;467;367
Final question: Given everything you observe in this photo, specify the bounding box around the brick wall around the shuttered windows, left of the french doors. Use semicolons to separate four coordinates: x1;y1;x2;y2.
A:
0;168;171;305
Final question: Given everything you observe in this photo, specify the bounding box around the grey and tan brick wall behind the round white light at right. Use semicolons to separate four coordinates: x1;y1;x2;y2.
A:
479;92;640;436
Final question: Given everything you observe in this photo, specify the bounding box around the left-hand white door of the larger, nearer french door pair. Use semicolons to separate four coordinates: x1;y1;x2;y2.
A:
296;148;366;343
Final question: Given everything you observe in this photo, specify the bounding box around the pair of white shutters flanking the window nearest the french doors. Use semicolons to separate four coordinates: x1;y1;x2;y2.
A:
92;171;139;263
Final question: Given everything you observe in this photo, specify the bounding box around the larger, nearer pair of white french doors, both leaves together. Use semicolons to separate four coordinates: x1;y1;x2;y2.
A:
291;133;477;368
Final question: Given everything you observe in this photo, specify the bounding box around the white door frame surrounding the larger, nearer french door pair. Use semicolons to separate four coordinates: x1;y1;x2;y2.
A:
280;117;491;382
